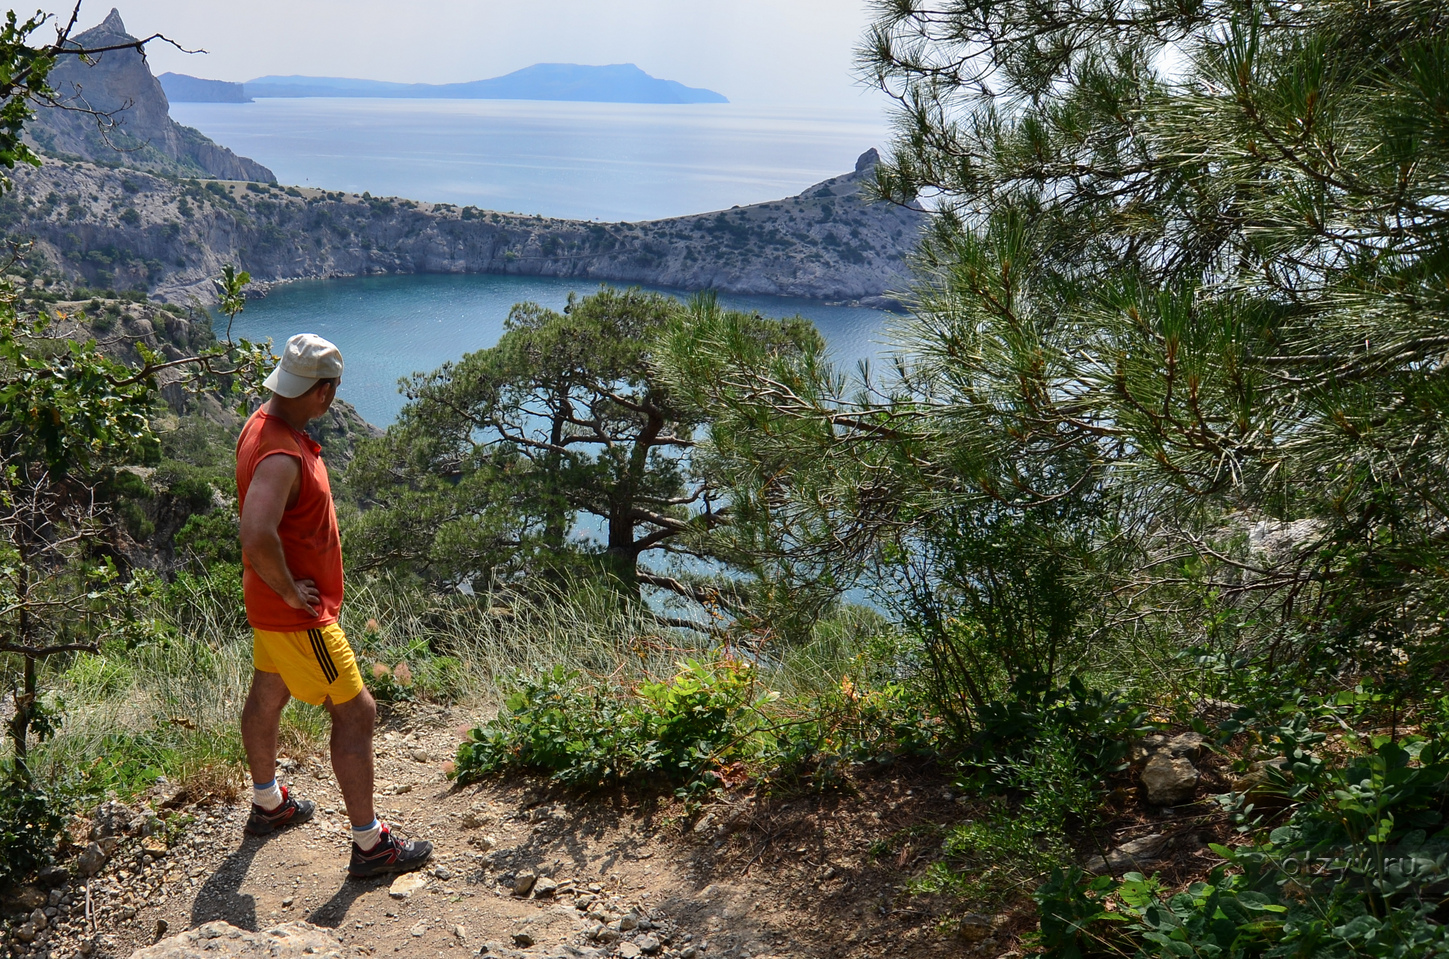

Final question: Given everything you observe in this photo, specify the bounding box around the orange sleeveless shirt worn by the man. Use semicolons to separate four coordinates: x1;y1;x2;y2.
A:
236;407;342;633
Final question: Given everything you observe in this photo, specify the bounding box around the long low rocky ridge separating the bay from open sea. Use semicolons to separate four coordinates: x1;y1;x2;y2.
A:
0;151;926;301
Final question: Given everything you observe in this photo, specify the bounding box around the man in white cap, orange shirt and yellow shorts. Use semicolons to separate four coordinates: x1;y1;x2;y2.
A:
236;333;433;878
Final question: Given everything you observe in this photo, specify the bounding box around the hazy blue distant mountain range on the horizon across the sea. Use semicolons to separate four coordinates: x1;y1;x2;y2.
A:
158;64;729;103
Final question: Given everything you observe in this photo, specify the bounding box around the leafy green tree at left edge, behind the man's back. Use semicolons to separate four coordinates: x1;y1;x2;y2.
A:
0;266;265;778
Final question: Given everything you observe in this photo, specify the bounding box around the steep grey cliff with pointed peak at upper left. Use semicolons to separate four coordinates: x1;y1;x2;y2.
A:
26;10;277;183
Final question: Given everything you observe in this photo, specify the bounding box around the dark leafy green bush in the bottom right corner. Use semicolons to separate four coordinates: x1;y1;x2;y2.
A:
1036;735;1449;959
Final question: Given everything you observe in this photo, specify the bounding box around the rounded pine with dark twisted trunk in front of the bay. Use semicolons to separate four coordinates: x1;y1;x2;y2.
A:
345;288;804;604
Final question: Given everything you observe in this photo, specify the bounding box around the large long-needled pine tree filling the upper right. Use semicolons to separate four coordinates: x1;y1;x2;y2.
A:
666;0;1449;706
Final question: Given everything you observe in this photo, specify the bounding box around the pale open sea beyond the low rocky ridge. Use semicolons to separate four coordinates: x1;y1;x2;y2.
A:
171;99;888;220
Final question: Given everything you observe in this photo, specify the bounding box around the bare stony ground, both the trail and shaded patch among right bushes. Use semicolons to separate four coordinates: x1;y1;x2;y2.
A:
0;704;1252;959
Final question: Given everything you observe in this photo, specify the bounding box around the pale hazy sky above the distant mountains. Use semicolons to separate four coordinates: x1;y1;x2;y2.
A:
36;0;882;110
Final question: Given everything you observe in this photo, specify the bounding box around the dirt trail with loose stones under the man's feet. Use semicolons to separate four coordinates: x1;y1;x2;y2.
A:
2;708;985;959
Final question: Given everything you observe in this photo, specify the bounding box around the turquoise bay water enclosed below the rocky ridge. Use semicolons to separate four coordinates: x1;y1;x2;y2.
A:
230;274;891;426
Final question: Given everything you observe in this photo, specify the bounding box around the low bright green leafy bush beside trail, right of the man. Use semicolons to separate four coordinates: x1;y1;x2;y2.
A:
455;659;775;788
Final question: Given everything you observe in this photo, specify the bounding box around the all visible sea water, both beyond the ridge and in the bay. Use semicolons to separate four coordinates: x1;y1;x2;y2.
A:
171;97;891;426
